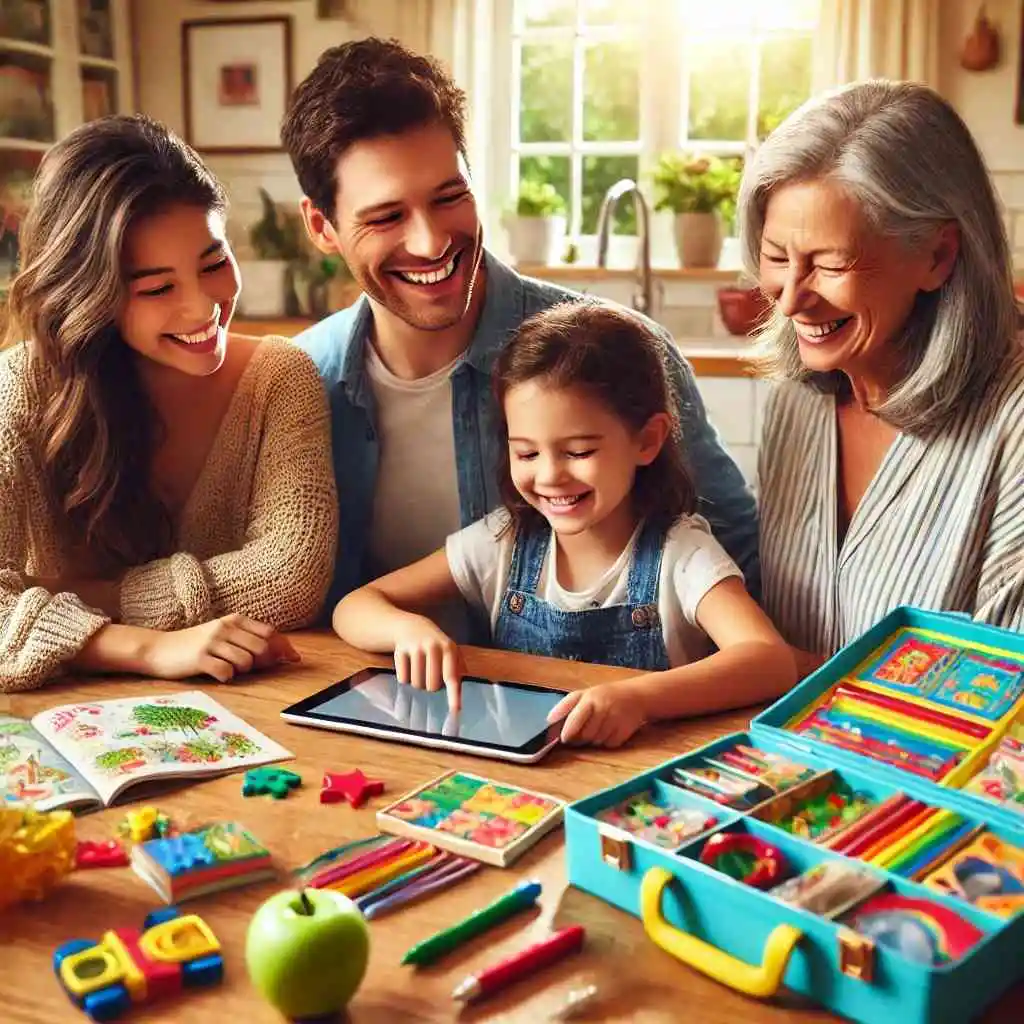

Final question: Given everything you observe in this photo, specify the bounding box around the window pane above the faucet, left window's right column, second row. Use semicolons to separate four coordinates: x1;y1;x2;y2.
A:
583;42;640;142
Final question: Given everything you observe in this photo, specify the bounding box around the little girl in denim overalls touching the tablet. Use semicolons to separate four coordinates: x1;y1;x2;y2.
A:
334;303;797;746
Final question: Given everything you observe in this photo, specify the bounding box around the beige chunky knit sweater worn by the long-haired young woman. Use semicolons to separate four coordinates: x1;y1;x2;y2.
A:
0;338;338;691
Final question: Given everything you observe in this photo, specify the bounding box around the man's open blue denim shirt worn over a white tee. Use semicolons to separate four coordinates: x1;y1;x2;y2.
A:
296;253;761;610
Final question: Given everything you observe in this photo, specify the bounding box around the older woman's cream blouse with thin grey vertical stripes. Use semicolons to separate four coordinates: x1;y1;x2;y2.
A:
758;361;1024;655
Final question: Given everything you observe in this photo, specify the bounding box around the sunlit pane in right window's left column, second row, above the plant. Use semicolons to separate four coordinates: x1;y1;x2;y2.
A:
687;39;751;142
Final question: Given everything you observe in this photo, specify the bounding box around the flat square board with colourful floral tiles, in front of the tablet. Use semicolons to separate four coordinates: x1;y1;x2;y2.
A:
377;771;565;867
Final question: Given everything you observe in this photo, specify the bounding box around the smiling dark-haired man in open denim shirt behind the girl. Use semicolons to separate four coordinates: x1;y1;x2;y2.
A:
282;38;759;632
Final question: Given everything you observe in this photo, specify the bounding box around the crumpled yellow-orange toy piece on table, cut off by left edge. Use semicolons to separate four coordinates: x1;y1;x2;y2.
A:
0;808;76;910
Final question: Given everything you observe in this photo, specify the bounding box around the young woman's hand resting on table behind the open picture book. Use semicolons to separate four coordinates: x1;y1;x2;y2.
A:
142;613;300;683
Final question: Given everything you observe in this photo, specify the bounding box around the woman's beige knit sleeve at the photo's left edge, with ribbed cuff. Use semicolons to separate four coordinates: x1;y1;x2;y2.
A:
0;423;110;693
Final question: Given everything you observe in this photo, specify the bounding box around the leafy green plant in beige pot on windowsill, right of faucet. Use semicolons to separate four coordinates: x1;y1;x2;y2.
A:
653;153;742;267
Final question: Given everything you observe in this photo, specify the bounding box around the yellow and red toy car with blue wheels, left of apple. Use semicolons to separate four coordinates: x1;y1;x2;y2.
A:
53;907;224;1021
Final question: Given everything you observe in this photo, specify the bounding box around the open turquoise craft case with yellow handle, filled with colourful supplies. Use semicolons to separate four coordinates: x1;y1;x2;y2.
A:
565;607;1024;1024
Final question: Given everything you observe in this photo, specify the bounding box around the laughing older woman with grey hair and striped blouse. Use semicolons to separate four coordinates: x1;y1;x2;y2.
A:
739;81;1024;671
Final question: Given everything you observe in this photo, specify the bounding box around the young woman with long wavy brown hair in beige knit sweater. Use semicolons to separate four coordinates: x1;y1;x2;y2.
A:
0;117;337;690
